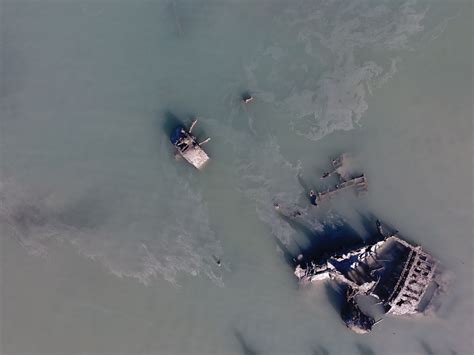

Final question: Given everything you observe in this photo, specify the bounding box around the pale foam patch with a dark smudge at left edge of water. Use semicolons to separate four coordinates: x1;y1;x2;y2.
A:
0;166;223;286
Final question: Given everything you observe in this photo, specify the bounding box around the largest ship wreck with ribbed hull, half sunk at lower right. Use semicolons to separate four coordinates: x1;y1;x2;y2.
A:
295;221;438;333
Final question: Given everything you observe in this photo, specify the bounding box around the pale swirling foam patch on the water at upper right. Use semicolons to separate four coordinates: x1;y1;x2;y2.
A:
246;0;427;140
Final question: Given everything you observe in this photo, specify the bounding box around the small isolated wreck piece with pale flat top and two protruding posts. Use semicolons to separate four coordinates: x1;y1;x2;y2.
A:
170;120;211;170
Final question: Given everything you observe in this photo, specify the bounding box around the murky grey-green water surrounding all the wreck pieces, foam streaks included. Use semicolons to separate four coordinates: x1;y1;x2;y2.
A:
0;0;473;354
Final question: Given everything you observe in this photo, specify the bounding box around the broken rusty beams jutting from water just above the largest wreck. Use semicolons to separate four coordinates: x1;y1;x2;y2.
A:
316;153;368;204
